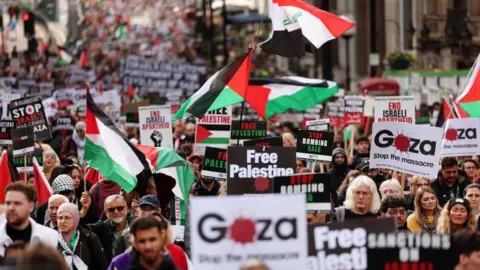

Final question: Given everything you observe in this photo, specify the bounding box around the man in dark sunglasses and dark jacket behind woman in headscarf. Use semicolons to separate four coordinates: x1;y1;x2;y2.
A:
88;195;131;263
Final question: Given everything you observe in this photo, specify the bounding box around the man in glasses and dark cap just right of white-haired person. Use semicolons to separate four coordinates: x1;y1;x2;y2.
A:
380;196;408;230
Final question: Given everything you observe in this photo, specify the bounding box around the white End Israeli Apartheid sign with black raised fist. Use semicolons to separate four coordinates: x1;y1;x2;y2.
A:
138;106;173;148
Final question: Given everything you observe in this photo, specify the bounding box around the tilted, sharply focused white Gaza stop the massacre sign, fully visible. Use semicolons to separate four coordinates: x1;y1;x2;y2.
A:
370;122;443;179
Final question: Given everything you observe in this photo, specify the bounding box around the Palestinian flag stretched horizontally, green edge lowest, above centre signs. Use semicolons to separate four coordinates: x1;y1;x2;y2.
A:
248;76;338;119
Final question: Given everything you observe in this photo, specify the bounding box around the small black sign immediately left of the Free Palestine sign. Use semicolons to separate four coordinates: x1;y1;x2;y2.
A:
202;146;227;180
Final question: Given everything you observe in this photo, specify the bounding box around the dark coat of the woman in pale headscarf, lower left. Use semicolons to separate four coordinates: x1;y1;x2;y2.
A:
59;227;108;270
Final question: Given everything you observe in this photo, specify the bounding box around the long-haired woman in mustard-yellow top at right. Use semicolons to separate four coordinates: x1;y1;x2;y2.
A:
407;187;442;232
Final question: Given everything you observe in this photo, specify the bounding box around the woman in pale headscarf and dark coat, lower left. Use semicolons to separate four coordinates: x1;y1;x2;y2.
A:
57;203;108;270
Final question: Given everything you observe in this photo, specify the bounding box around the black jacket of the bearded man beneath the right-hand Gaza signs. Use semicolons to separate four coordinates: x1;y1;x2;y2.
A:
430;170;471;207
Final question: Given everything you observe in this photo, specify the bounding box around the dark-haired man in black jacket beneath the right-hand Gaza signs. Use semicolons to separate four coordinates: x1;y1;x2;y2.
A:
430;157;471;207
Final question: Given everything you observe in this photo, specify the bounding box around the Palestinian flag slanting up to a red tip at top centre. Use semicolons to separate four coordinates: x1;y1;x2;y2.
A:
172;49;255;121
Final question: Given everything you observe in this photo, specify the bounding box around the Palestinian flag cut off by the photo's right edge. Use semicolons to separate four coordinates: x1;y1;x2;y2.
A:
455;54;480;117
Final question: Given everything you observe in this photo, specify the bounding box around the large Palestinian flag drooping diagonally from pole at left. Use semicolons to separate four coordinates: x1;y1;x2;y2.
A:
84;91;151;194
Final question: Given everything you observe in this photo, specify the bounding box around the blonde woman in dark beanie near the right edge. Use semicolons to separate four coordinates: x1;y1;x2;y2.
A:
437;198;476;234
